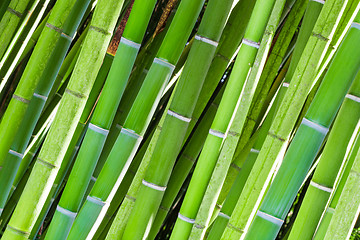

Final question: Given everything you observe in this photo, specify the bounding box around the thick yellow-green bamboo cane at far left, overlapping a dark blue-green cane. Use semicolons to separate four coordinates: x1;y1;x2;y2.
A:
0;0;74;169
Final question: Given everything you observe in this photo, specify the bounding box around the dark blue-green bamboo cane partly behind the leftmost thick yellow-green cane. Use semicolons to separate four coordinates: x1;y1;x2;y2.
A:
0;0;90;212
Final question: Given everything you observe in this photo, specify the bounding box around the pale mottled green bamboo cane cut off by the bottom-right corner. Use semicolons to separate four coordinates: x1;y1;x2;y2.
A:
324;151;360;240
